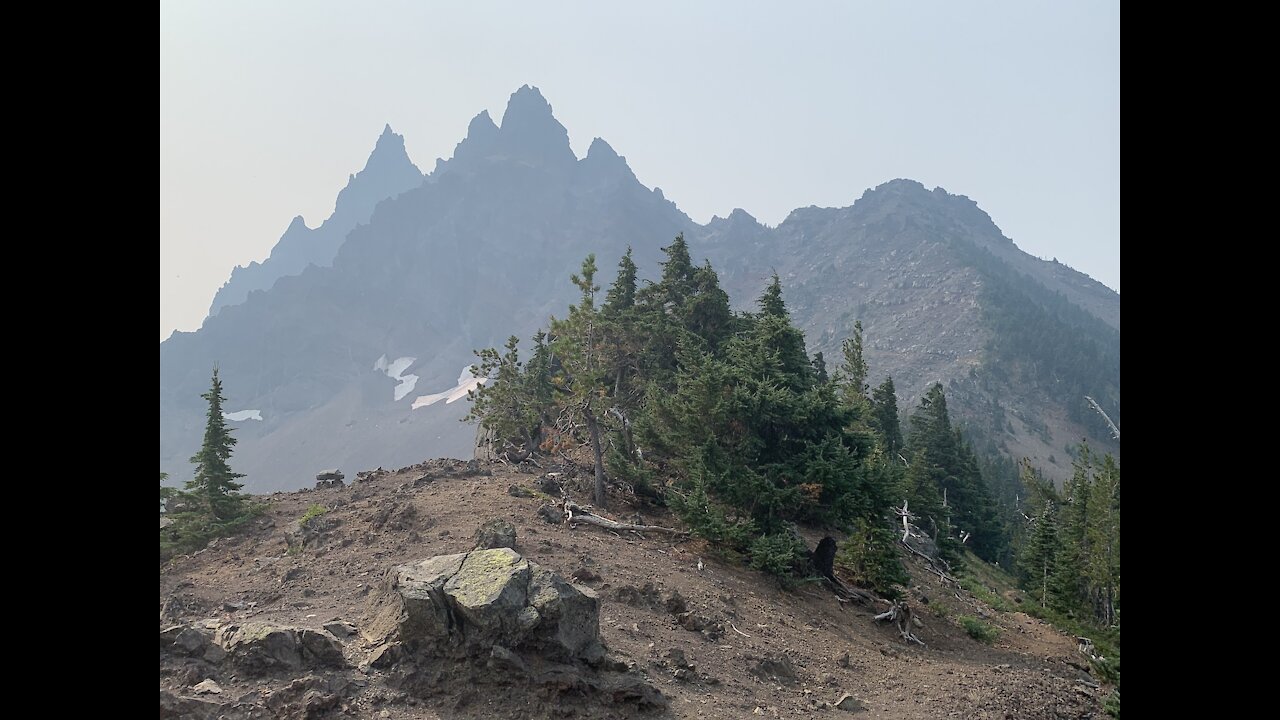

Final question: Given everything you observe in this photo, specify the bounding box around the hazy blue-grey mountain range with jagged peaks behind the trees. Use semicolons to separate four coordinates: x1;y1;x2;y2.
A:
160;86;1120;491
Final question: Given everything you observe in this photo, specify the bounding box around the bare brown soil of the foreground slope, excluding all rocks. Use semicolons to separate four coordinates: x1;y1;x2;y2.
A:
160;460;1103;719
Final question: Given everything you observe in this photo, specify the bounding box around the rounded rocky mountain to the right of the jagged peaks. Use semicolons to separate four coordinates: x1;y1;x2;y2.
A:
701;179;1120;486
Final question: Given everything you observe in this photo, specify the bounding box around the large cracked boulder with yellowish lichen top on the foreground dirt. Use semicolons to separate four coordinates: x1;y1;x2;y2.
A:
361;547;666;715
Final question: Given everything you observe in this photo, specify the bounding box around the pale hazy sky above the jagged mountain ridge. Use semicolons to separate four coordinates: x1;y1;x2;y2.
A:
160;0;1120;340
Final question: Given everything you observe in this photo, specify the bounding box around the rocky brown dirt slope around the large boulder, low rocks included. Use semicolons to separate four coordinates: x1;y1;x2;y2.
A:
160;460;1103;719
